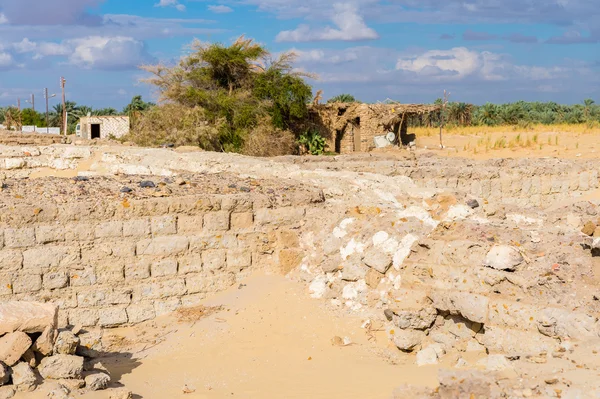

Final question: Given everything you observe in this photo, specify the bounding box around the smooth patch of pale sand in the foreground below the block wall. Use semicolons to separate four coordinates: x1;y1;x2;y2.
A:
21;275;438;399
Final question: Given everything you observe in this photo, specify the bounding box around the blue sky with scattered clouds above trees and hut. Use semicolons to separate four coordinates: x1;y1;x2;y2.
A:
0;0;600;109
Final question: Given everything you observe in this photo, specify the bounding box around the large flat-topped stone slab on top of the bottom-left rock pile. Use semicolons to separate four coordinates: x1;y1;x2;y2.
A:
0;301;58;335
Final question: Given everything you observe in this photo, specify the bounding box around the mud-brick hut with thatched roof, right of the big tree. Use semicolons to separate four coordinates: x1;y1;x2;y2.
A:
310;103;440;154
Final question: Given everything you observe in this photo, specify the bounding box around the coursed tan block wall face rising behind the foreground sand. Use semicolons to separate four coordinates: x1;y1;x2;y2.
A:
0;195;305;326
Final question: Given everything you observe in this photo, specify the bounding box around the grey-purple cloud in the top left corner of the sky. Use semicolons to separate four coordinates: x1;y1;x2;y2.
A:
0;0;104;25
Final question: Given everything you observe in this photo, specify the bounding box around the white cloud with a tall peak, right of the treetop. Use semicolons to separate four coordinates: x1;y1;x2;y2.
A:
276;3;379;42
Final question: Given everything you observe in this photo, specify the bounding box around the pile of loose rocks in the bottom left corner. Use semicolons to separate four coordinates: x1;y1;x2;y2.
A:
0;301;118;399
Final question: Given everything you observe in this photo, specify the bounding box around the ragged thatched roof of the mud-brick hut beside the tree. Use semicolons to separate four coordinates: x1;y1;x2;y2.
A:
310;103;440;130
